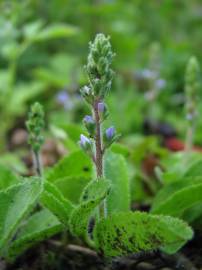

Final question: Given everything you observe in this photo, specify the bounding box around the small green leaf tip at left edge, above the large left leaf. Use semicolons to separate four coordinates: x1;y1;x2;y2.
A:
0;164;20;190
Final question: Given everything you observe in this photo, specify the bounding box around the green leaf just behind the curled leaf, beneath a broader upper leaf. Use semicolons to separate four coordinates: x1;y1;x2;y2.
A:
54;175;90;204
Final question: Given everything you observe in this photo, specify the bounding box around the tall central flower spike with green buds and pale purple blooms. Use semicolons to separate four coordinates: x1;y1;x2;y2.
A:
80;34;117;216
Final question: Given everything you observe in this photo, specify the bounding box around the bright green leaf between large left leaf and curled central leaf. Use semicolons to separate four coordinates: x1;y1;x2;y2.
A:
41;181;74;226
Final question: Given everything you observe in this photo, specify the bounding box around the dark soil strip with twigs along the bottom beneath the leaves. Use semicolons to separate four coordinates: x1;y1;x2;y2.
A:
0;233;202;270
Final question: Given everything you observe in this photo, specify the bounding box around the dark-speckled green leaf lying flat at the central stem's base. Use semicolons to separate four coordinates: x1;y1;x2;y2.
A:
94;212;193;257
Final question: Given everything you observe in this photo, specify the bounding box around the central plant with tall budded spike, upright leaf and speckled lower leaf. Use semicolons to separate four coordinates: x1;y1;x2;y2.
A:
64;34;193;257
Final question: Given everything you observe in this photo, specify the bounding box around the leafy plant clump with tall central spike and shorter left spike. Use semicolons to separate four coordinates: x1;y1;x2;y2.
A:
0;34;193;260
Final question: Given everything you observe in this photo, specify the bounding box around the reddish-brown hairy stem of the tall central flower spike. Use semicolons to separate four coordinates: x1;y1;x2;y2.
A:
93;100;105;218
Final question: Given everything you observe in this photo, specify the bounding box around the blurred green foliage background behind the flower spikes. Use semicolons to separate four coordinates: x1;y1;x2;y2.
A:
0;0;202;152
